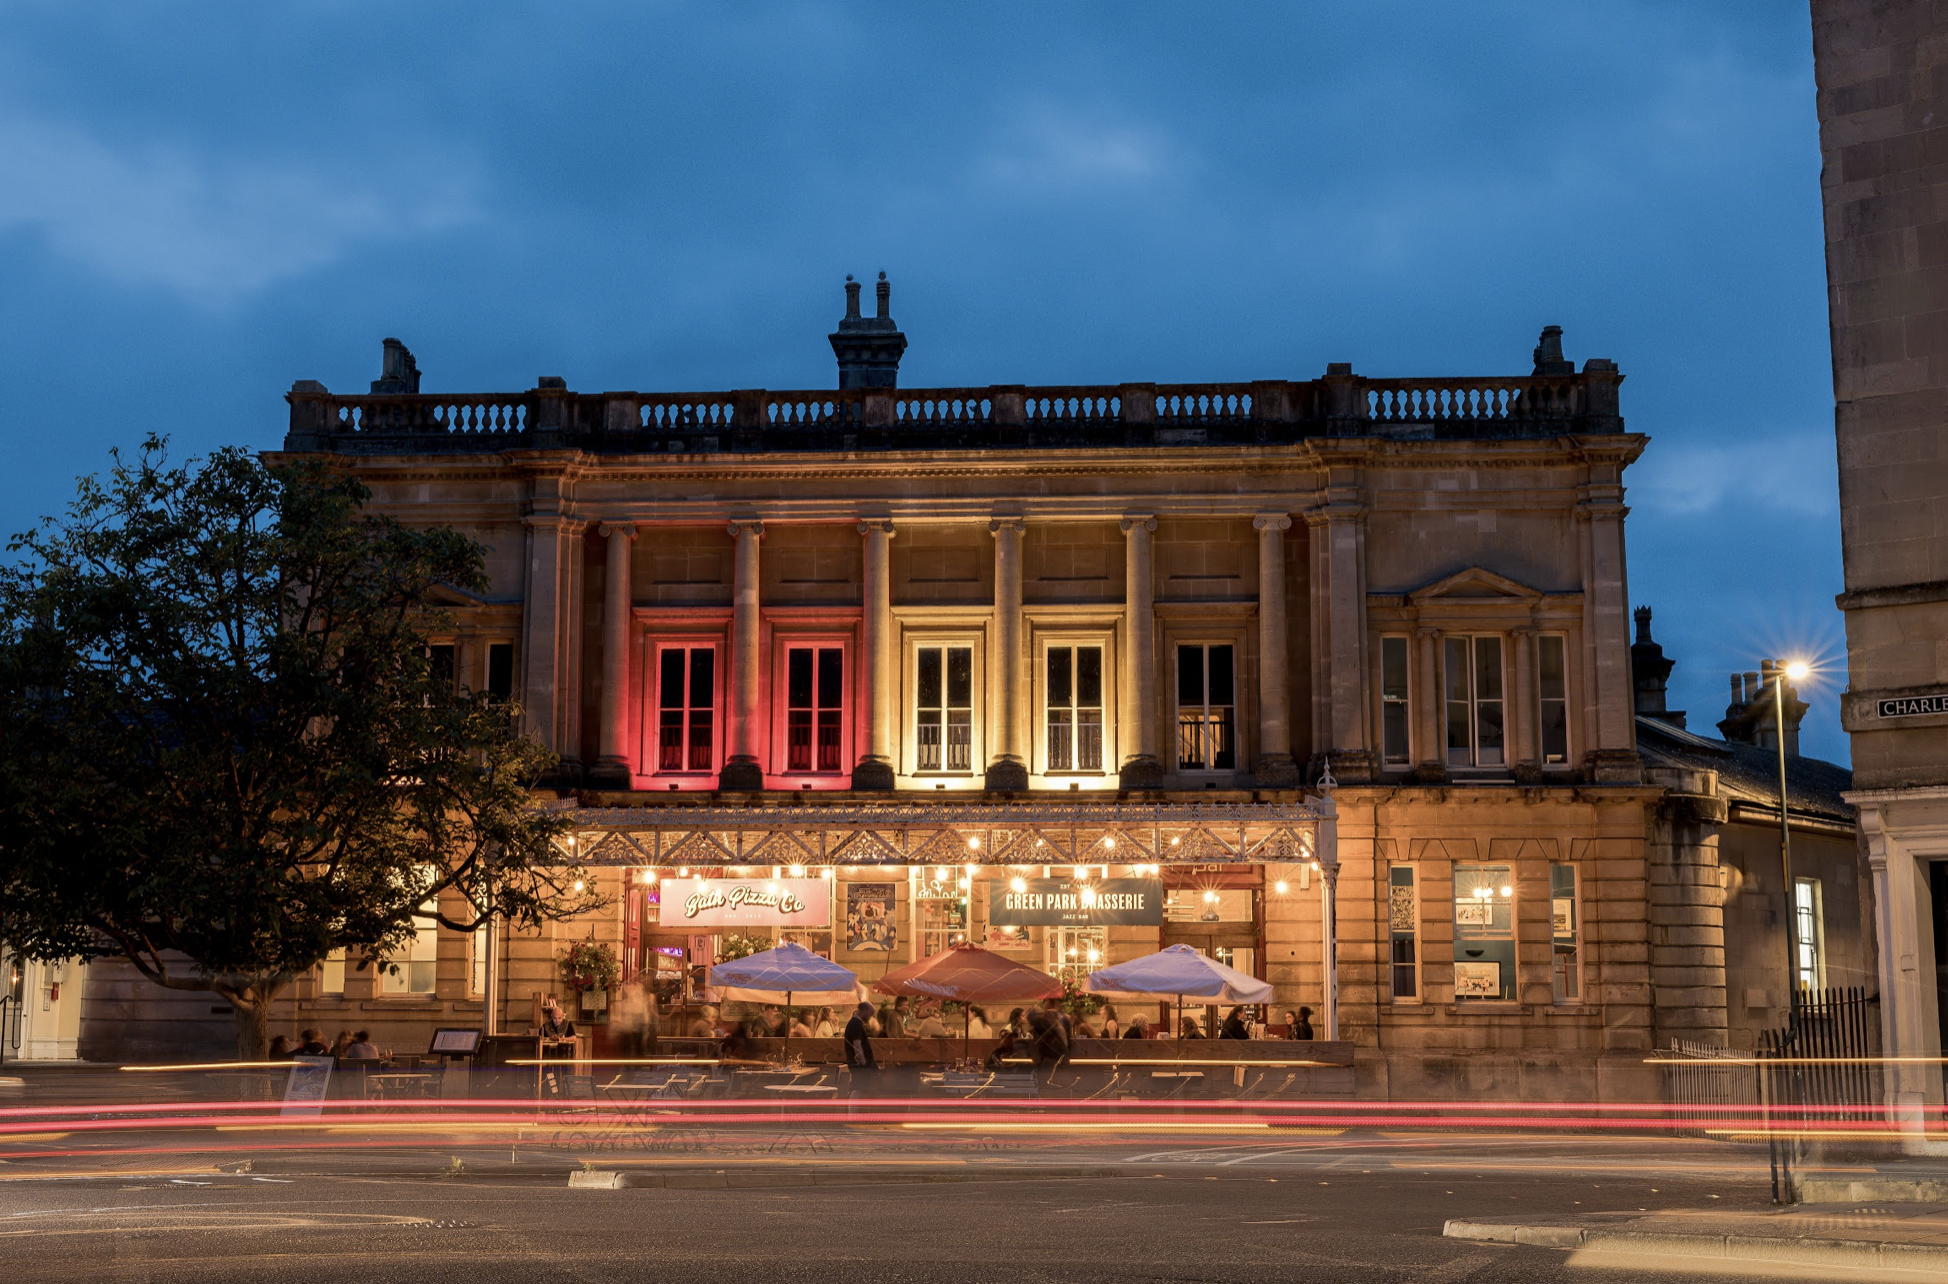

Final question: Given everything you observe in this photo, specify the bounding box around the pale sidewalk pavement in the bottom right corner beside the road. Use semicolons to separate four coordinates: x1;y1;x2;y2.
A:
1442;1202;1948;1280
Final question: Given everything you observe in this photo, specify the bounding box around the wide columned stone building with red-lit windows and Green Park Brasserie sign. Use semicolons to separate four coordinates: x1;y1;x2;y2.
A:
247;281;1823;1099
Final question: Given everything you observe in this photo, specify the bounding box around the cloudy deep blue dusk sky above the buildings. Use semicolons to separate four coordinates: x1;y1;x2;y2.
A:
0;0;1847;762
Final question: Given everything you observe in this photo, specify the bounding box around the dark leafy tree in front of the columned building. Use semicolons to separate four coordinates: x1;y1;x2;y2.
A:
0;438;598;1058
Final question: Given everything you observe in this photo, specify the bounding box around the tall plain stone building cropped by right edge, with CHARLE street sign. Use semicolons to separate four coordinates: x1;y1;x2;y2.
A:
1812;0;1948;1130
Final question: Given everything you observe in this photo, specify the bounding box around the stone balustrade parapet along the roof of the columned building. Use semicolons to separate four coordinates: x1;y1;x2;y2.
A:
284;360;1623;456
